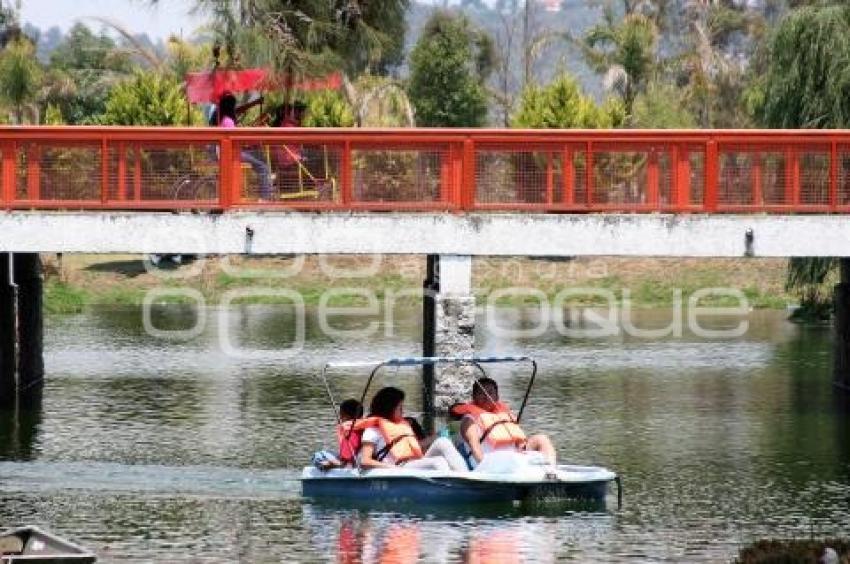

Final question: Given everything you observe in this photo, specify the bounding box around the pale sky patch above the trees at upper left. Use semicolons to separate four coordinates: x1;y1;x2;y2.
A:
21;0;201;40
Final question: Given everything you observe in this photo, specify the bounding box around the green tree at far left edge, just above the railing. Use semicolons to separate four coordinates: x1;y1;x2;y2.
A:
0;37;43;124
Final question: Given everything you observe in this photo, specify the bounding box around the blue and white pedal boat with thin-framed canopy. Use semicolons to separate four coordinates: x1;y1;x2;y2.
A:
301;356;622;505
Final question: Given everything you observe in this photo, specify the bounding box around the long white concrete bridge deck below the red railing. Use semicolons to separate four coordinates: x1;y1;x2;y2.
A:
0;211;850;257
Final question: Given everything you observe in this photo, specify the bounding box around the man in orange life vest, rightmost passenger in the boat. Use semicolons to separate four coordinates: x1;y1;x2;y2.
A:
449;378;556;468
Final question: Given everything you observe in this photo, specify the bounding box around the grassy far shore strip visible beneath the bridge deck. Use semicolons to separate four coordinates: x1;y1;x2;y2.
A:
42;254;797;314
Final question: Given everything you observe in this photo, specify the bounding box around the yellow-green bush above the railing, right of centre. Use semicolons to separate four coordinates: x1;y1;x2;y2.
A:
513;74;625;129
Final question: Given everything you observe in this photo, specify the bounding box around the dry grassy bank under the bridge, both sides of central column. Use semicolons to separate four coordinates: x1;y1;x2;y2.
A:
44;255;794;311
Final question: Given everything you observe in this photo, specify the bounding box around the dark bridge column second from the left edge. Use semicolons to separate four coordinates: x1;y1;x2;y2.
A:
14;253;44;407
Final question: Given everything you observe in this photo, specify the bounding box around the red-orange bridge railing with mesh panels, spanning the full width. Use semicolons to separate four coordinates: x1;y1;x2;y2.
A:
0;127;850;213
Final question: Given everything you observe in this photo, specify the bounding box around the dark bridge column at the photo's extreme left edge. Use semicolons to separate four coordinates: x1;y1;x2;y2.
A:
0;253;18;409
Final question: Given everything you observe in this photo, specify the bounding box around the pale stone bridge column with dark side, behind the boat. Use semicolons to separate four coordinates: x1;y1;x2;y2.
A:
422;255;475;414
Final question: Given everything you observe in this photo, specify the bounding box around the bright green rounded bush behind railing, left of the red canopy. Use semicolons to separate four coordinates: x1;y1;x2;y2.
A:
97;71;201;126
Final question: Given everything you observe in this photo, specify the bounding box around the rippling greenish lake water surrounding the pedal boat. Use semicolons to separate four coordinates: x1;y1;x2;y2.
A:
0;306;850;563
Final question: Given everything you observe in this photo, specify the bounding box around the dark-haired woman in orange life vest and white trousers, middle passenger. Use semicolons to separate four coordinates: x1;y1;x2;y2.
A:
354;387;467;471
